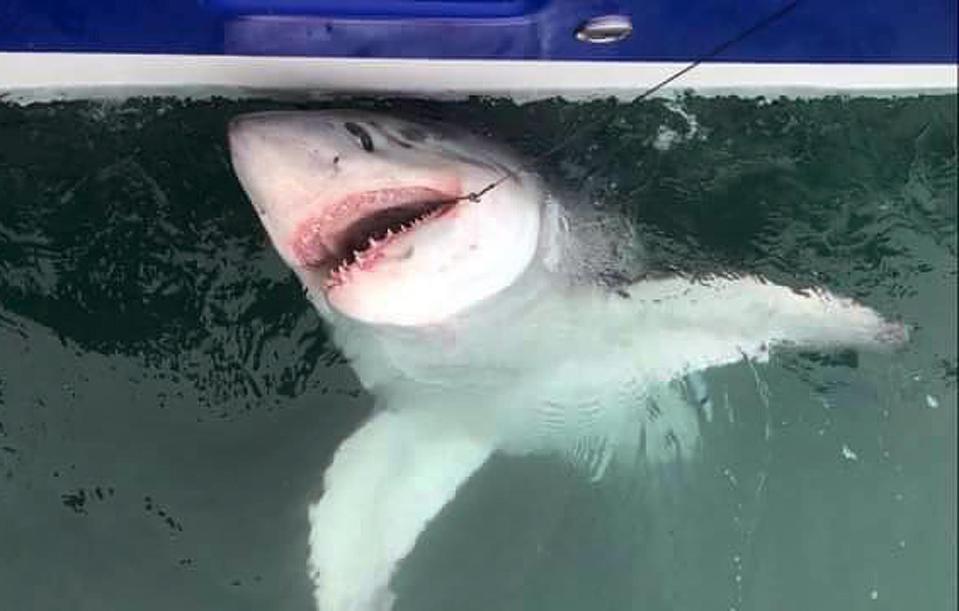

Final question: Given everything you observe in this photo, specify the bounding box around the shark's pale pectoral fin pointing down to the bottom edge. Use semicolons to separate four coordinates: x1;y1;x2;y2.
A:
309;408;493;611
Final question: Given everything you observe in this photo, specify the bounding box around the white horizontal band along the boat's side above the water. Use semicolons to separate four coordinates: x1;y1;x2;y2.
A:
0;53;957;101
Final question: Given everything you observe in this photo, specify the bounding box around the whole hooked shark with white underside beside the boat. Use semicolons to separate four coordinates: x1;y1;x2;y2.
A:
228;109;908;611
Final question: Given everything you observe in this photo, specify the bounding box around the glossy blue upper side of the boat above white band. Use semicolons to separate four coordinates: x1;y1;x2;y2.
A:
0;0;957;64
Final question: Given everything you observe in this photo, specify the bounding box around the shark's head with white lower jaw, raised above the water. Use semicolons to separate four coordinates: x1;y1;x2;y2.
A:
229;110;543;326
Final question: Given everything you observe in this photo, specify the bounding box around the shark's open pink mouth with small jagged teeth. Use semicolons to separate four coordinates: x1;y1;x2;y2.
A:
296;187;458;285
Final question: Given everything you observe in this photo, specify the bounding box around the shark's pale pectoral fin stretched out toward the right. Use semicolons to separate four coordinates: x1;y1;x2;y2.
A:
617;276;908;381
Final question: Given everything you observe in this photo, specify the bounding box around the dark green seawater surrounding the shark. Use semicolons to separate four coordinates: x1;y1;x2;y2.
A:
0;96;957;611
